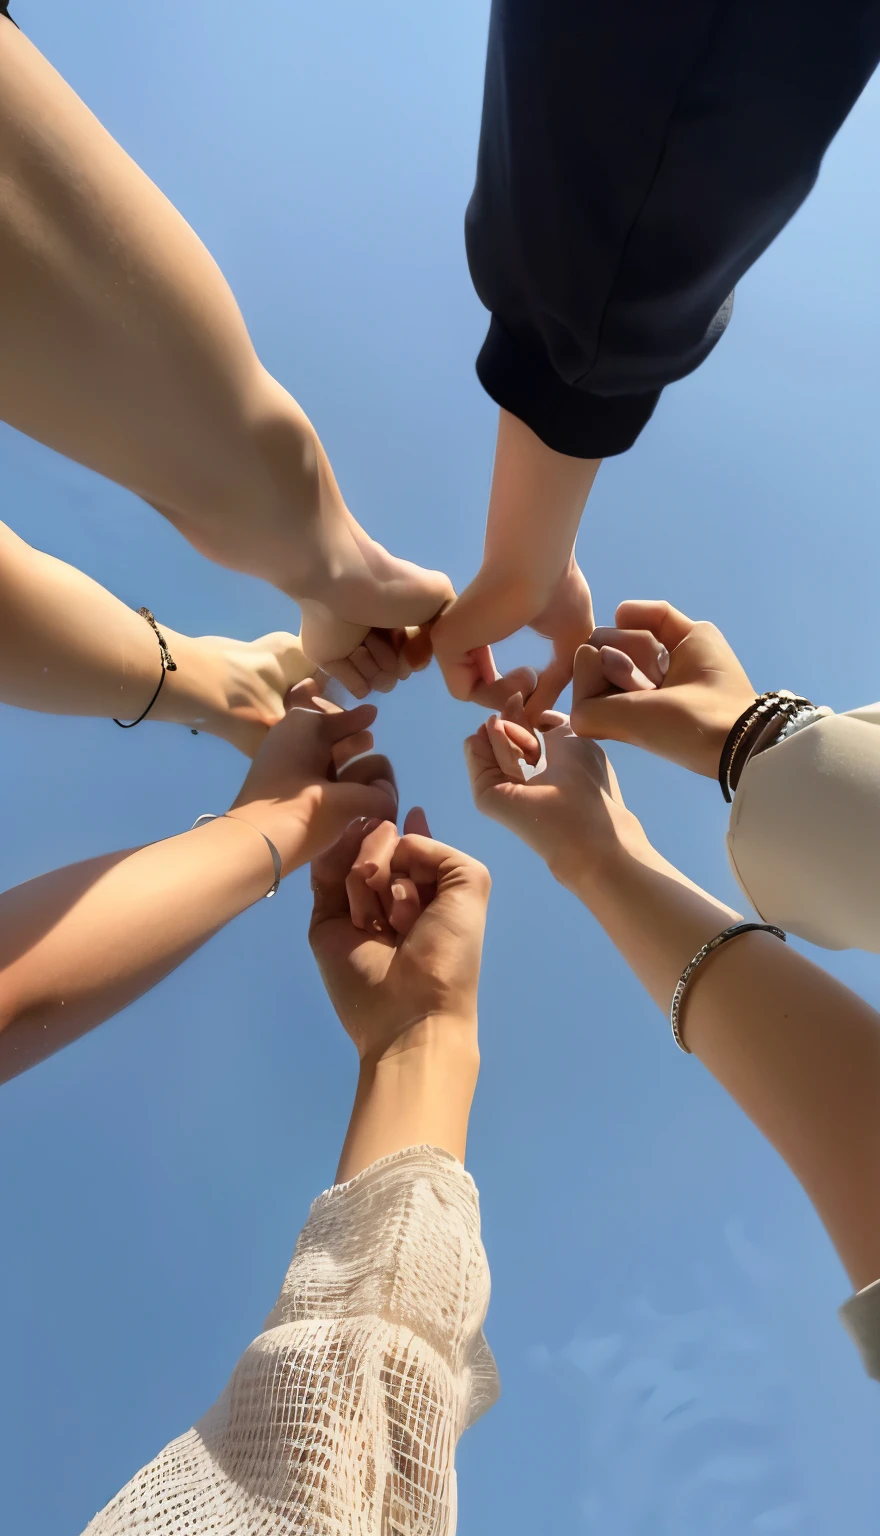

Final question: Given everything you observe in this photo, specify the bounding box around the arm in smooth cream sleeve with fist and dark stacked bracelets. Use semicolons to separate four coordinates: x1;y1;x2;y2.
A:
571;602;880;954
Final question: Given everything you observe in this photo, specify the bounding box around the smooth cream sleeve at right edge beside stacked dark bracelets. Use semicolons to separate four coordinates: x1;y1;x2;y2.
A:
728;703;880;954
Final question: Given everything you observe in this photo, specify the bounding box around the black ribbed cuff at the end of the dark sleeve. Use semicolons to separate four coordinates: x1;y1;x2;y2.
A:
476;316;660;459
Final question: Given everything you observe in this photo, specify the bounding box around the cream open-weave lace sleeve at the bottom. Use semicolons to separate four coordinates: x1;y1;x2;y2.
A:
81;1147;498;1536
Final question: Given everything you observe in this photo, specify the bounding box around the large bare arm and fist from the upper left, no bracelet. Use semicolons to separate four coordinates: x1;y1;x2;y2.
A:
0;17;531;703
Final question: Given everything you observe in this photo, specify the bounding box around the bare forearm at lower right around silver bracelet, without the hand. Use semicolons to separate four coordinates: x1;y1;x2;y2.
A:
568;843;880;1289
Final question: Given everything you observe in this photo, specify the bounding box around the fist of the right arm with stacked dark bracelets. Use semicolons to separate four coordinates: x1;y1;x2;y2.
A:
571;602;756;779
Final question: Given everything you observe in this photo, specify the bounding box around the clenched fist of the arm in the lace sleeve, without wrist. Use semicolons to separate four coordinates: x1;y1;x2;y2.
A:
309;811;490;1061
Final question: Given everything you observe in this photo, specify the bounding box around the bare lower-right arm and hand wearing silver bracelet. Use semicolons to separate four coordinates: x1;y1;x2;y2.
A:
465;706;880;1290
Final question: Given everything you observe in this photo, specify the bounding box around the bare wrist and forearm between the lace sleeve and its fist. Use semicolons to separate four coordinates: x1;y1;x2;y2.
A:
336;1017;479;1184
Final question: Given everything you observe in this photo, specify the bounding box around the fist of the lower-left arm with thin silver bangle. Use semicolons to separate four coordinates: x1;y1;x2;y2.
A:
230;679;398;874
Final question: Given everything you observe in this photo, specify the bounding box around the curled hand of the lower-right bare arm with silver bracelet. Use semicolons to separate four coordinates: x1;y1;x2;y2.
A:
464;700;645;894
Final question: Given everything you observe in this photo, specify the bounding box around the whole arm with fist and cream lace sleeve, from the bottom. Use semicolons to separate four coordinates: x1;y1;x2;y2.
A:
88;819;498;1536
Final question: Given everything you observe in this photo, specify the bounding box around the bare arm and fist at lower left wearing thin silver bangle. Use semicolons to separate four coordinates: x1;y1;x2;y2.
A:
0;680;398;1081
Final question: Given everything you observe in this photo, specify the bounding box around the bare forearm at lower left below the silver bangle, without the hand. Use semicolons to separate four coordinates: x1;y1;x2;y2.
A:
0;819;272;1081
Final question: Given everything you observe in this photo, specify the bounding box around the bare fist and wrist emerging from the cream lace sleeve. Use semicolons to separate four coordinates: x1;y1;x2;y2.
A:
309;811;490;1183
